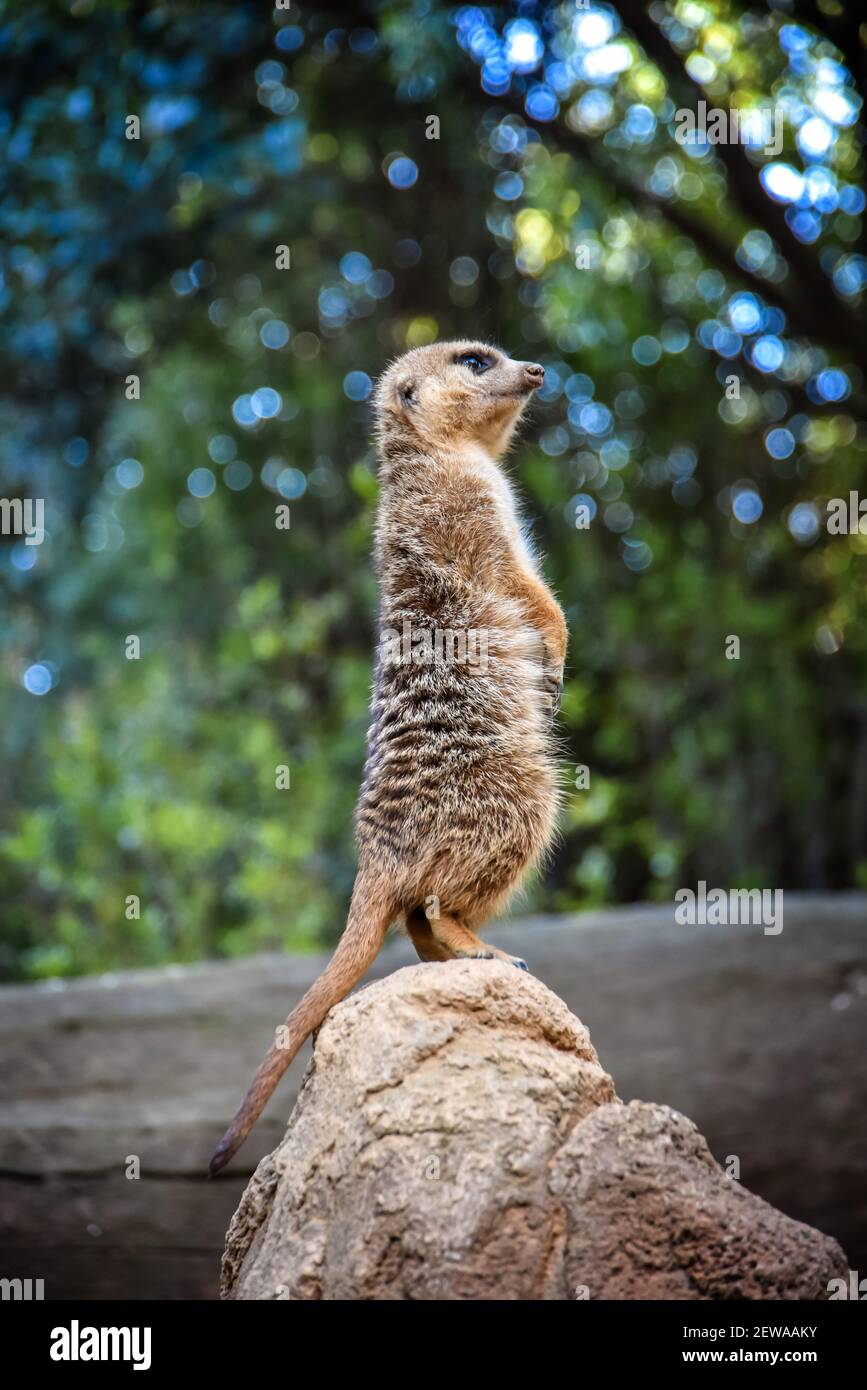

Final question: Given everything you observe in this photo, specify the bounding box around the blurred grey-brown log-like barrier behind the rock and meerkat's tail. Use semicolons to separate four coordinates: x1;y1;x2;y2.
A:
0;891;867;1301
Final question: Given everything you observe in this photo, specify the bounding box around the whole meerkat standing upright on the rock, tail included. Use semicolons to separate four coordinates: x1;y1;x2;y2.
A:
210;342;567;1176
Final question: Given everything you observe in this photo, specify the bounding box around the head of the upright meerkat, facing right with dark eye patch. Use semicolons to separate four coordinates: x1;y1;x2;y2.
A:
374;339;545;459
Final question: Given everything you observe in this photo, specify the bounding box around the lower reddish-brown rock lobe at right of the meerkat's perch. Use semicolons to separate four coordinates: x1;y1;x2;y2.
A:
549;1101;846;1300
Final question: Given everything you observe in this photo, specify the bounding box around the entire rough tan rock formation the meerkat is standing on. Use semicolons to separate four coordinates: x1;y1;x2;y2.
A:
222;960;848;1300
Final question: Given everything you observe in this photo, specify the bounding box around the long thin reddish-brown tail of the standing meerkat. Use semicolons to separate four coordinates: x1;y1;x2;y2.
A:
208;877;396;1177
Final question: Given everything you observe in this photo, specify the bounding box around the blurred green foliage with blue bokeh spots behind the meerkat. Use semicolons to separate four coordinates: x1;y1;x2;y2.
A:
0;0;867;981
